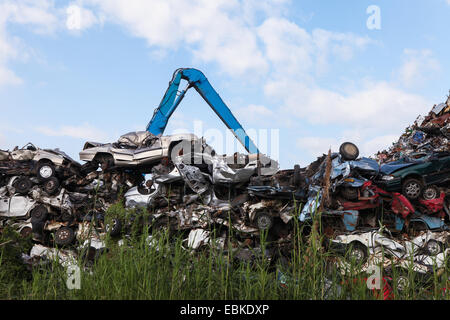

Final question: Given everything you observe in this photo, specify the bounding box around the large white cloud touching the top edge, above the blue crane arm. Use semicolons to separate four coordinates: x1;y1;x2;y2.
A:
85;0;267;75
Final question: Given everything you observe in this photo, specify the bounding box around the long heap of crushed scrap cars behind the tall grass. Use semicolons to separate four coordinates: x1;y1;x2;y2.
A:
0;101;450;288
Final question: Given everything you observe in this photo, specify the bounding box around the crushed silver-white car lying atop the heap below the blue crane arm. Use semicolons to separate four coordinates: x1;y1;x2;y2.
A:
80;131;201;170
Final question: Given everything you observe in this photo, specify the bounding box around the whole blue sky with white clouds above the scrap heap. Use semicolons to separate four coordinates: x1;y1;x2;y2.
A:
0;0;450;168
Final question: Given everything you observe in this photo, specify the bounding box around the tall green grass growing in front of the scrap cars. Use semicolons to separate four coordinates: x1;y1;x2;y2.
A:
0;205;449;300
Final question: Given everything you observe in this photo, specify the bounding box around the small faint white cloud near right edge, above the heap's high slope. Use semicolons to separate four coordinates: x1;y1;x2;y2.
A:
395;49;441;87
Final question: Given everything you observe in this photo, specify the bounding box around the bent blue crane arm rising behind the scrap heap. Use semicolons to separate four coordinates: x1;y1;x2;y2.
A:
146;68;259;153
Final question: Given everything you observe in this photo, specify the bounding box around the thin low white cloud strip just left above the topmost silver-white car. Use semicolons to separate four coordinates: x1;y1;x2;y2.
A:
36;123;111;142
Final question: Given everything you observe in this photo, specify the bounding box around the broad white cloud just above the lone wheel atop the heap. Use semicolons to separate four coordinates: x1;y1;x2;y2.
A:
282;78;432;161
